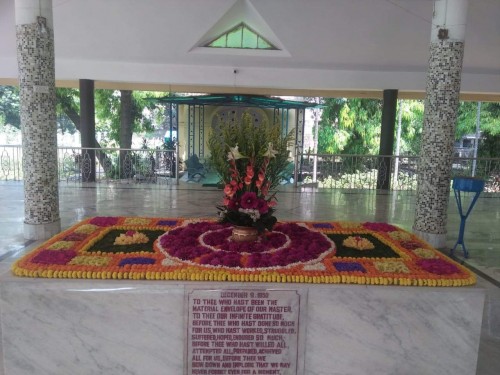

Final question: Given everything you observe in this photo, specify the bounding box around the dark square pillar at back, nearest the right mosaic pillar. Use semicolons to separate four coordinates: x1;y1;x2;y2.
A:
377;90;398;190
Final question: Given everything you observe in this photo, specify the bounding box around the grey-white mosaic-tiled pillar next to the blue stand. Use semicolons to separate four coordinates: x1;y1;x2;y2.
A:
413;0;468;248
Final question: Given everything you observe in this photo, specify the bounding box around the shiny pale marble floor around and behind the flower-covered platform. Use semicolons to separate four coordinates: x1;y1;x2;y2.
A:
0;182;500;375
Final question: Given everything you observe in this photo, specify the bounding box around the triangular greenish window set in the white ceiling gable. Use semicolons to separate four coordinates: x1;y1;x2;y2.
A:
205;22;278;50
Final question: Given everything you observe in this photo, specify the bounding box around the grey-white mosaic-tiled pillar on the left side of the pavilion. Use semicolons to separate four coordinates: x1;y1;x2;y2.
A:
16;0;61;240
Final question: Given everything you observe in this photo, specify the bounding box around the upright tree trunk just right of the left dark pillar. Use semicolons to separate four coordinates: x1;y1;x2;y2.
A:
120;90;134;178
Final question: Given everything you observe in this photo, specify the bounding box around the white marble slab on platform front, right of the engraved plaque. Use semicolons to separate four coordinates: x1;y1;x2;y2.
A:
306;287;484;375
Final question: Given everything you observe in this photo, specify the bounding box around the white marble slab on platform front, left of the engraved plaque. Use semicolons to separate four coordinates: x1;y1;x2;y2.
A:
2;280;184;375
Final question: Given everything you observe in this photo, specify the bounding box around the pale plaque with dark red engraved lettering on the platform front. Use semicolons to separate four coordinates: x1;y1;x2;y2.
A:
186;289;301;375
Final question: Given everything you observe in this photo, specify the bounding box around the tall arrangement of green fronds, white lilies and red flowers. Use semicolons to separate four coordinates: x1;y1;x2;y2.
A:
208;113;293;233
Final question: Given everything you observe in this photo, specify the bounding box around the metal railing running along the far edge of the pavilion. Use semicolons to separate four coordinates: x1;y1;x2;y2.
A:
0;145;500;193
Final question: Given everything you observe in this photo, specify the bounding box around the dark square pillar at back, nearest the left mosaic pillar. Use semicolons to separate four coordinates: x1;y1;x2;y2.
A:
80;79;96;182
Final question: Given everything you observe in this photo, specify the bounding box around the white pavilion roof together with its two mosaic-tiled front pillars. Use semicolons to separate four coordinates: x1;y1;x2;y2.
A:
0;0;500;247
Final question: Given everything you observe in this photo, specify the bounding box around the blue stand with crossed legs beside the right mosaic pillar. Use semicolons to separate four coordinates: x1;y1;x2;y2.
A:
450;177;484;258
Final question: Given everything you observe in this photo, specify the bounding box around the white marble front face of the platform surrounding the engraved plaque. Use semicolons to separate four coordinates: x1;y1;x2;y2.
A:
0;273;485;375
